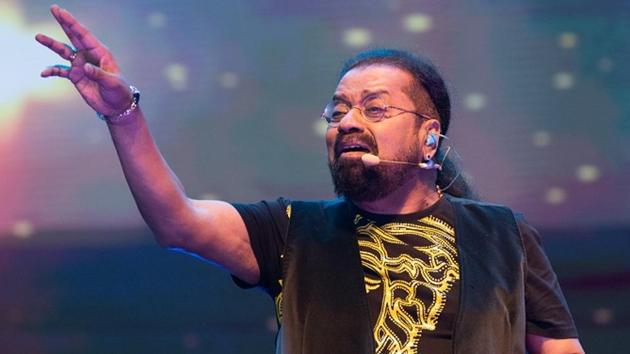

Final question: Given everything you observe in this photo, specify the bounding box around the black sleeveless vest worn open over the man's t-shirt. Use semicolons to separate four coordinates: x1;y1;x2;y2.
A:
276;197;526;354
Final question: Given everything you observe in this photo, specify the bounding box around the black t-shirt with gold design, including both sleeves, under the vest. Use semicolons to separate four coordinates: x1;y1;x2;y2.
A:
233;198;577;354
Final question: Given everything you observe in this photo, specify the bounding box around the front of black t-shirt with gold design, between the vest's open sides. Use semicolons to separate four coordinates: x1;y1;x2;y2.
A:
354;198;459;354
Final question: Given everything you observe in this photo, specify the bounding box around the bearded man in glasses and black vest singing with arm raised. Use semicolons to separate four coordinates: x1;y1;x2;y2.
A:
36;6;583;353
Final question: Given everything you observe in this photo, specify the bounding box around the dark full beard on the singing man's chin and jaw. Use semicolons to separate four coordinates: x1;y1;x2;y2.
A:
328;134;420;202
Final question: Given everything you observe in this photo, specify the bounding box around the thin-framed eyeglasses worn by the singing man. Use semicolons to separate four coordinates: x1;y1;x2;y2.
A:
322;101;431;128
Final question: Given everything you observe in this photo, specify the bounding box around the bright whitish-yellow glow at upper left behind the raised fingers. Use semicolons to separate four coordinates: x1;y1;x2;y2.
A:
0;1;73;142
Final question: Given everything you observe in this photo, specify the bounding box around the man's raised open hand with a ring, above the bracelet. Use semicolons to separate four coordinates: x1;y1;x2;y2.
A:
35;5;133;116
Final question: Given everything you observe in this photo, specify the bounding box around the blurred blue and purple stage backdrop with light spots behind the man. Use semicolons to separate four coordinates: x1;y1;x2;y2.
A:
0;0;630;353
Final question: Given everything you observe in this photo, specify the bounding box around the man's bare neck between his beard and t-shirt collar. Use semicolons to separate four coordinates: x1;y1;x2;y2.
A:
352;172;440;214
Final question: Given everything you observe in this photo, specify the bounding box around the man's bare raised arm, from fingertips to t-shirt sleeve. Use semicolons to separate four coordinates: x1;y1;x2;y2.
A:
35;5;259;283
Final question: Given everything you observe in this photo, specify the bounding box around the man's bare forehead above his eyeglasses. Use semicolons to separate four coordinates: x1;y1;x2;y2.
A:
335;64;413;100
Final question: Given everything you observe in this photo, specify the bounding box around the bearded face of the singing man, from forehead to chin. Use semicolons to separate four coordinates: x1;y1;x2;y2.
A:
326;65;425;202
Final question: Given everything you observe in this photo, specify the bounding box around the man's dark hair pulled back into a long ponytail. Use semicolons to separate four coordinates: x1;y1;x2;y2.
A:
338;48;477;199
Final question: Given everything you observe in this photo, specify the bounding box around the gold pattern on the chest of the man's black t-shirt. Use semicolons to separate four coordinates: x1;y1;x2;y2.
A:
355;215;459;354
